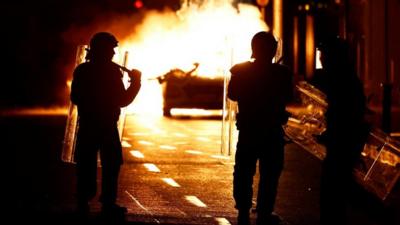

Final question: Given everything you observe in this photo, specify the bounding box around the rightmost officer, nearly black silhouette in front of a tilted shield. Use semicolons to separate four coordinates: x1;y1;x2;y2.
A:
312;37;369;225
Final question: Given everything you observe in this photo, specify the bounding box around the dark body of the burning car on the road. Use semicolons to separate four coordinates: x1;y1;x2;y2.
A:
157;63;224;116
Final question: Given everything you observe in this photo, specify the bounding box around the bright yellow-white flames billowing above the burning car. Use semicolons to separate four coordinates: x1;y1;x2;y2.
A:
120;0;268;112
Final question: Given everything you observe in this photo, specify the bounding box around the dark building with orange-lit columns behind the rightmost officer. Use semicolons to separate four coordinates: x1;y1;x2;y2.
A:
265;0;400;132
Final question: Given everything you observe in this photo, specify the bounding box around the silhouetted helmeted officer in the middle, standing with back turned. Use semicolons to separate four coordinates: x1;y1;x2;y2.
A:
228;32;293;225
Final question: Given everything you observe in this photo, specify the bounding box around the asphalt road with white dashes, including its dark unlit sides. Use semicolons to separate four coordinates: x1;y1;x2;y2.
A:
1;110;396;225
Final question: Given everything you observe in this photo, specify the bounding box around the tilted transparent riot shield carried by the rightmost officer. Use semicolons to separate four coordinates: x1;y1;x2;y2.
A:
284;81;400;201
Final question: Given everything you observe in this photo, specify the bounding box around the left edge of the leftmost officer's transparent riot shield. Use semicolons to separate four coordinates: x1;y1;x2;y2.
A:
61;45;87;163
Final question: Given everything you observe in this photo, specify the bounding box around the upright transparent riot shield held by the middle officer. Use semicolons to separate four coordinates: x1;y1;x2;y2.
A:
221;38;282;156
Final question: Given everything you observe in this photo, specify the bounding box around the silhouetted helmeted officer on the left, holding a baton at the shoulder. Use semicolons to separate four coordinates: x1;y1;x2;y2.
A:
71;32;141;214
